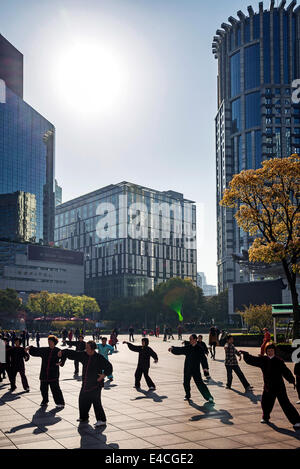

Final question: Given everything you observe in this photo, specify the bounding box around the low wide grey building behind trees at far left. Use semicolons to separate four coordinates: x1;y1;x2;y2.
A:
0;241;84;301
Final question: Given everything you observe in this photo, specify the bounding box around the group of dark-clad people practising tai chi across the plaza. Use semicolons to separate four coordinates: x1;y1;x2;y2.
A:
0;330;300;429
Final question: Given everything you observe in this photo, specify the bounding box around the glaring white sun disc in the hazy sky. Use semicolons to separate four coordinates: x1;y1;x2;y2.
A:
55;41;129;115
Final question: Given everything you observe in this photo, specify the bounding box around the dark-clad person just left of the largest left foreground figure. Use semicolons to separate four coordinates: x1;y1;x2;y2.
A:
26;335;65;408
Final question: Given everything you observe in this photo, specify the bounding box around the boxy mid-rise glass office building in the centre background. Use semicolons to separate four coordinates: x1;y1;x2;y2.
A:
55;182;197;309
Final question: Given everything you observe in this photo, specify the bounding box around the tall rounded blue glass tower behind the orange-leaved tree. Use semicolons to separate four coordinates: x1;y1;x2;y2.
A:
212;1;300;291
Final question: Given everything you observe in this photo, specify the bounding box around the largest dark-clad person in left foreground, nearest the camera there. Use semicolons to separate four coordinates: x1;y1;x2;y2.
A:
59;340;112;427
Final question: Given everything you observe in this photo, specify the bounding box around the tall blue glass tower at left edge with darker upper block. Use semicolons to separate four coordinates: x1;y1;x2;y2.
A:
0;36;55;243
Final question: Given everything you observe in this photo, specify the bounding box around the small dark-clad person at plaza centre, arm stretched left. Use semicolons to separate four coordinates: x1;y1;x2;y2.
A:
123;337;158;391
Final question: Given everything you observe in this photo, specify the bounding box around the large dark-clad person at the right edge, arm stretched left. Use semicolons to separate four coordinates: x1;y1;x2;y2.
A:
240;344;300;429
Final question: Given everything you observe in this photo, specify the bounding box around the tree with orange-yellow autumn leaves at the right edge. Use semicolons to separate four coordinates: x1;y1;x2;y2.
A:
220;155;300;339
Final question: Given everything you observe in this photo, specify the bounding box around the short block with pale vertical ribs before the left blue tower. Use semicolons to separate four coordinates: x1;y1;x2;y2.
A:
0;191;36;242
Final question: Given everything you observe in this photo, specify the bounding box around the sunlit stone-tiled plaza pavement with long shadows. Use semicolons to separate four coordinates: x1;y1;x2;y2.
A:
0;336;300;450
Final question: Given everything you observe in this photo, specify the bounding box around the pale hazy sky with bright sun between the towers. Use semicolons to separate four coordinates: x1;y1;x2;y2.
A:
0;0;269;284
